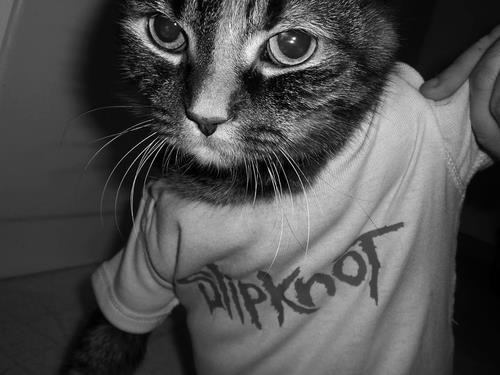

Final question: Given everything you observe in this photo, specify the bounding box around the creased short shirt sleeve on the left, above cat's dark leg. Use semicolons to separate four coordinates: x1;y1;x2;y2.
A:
92;188;178;333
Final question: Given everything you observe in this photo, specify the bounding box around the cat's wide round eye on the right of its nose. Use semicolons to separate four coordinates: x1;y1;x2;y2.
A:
267;30;318;66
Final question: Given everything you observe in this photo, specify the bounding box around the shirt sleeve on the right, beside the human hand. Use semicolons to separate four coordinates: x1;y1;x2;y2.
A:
431;82;493;189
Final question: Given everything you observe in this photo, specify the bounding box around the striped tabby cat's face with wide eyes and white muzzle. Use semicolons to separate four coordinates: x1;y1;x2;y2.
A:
123;0;395;195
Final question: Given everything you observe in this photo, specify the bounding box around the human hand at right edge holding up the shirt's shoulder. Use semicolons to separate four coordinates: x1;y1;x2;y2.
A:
420;25;500;160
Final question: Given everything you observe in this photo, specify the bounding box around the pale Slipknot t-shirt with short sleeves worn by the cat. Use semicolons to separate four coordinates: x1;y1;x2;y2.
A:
93;64;490;375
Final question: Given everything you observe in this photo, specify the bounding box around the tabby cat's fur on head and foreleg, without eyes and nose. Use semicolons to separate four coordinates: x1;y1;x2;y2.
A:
65;0;397;375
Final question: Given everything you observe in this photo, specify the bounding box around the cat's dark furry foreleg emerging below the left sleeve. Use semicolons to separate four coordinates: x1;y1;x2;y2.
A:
62;311;149;375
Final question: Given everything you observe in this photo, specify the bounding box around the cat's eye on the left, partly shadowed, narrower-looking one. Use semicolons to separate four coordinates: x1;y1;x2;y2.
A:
148;14;187;52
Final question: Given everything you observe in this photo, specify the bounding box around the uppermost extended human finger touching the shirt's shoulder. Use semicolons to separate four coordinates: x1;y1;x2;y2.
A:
420;25;500;100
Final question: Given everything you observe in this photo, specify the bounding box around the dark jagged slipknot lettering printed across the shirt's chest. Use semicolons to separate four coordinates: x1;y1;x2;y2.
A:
178;223;404;329
